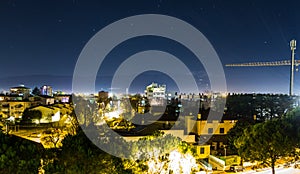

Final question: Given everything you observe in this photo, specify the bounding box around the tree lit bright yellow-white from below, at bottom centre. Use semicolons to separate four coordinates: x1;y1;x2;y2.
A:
123;132;197;174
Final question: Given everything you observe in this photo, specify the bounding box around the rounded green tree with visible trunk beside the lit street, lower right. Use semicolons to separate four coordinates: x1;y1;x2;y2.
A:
234;119;294;174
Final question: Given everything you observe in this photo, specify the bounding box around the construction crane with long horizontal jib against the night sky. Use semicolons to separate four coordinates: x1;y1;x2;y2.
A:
225;39;300;96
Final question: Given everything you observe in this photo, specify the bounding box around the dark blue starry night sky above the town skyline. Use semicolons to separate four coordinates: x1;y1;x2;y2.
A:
0;0;300;94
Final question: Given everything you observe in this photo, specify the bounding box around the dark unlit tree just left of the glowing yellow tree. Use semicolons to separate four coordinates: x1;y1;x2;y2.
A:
44;128;125;174
